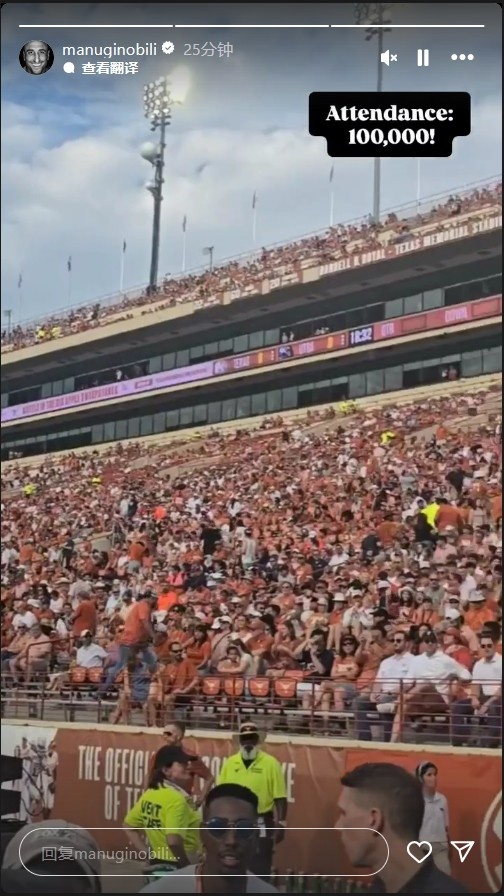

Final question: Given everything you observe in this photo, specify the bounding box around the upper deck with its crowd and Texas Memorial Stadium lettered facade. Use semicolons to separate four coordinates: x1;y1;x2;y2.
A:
2;183;502;373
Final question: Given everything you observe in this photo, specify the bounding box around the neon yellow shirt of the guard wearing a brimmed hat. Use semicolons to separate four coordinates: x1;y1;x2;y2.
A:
217;750;287;815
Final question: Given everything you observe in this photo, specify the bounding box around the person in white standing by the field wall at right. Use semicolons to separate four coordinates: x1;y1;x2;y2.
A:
416;762;451;874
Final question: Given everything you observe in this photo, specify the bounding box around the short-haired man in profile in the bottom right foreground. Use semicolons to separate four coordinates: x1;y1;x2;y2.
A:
336;762;469;894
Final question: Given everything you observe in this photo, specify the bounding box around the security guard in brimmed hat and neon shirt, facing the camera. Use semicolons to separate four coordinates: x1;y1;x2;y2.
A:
217;721;287;879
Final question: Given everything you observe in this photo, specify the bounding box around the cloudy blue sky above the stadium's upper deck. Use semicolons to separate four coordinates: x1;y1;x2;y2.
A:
2;4;502;319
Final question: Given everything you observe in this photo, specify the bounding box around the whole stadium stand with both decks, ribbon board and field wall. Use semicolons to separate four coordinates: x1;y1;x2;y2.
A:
2;173;502;892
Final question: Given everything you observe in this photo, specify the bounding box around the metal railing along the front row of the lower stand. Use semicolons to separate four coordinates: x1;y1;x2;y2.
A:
2;667;502;746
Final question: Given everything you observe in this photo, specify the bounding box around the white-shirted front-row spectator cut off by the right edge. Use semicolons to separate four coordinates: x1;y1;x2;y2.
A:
452;629;502;747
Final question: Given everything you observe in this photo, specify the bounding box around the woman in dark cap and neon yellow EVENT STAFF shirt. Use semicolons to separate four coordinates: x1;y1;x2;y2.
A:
123;746;201;871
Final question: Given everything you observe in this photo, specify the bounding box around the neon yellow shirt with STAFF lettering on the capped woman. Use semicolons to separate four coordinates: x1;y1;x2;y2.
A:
124;786;195;862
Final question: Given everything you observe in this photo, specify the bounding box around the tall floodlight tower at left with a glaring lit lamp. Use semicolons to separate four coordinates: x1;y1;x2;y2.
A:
140;77;187;294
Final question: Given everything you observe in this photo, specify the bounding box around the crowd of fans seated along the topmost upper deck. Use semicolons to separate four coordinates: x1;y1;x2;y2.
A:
2;183;502;351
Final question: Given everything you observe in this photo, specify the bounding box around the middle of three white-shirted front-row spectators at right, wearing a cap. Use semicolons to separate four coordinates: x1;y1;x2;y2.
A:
398;632;471;741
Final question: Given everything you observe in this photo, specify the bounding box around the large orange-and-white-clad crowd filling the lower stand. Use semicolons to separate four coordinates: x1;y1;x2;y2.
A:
1;387;502;746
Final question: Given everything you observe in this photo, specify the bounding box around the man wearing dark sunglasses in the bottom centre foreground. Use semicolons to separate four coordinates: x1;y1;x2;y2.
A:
141;784;278;896
